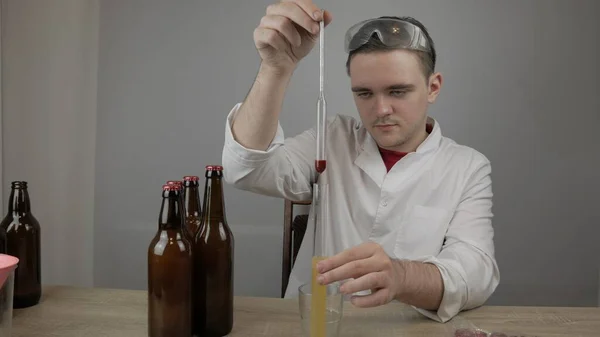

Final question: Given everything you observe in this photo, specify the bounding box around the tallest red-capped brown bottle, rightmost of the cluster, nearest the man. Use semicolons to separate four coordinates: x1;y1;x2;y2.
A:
194;166;234;337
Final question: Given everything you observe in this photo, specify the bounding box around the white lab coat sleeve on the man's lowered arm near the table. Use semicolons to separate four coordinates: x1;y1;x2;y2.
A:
415;158;500;322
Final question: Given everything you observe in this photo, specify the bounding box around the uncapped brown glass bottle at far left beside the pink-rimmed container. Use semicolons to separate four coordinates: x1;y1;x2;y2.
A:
0;181;42;308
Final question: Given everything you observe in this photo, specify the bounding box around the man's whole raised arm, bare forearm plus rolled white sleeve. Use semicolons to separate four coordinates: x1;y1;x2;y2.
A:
222;0;331;200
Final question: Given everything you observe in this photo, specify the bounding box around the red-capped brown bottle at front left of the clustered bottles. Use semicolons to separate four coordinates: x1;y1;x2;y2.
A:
148;184;193;337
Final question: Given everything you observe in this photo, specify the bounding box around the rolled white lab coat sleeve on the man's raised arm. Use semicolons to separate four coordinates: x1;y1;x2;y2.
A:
222;103;316;201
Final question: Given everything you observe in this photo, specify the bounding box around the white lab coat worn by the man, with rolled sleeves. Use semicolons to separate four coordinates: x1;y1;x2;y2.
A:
222;103;500;322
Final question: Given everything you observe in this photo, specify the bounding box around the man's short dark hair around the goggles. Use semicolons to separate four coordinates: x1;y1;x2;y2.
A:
346;16;436;79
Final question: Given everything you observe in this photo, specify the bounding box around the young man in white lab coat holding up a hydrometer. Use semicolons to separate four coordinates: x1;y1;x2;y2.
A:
223;0;499;322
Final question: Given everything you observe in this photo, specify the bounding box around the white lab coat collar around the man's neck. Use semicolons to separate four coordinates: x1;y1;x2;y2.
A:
354;117;442;188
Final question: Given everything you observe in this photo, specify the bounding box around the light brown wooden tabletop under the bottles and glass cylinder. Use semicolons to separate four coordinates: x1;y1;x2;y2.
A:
12;287;600;337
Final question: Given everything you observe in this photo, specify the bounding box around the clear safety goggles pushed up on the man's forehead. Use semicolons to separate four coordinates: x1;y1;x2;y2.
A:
344;18;430;53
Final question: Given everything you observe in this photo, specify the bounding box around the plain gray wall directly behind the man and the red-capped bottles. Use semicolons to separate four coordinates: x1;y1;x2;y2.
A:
94;0;600;305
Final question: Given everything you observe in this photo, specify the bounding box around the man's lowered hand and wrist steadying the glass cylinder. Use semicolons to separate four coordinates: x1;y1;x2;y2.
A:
317;242;444;310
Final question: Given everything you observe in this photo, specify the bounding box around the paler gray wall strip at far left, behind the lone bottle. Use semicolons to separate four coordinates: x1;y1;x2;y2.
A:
1;0;99;286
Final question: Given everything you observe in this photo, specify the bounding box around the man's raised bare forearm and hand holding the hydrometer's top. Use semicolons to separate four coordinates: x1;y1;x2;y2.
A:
232;0;331;151
